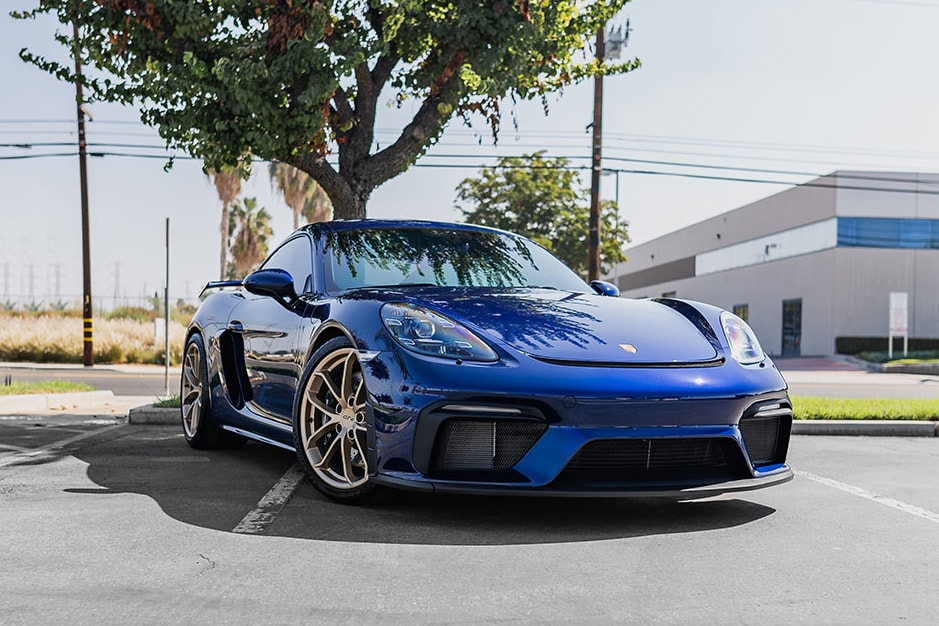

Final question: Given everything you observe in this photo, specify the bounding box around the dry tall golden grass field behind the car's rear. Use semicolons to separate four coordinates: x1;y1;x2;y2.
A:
0;315;186;364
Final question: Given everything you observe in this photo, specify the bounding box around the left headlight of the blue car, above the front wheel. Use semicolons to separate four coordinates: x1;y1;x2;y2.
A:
381;303;499;361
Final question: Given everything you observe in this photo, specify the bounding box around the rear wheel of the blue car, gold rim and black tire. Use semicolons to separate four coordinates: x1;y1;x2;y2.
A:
179;333;246;450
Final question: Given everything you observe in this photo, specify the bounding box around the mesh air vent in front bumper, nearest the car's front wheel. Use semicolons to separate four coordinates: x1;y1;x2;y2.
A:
432;419;547;472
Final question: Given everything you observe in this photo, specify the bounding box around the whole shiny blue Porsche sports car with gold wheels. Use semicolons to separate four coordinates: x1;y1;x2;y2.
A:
181;220;792;502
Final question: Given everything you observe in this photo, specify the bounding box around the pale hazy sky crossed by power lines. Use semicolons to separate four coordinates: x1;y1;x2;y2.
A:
0;0;939;310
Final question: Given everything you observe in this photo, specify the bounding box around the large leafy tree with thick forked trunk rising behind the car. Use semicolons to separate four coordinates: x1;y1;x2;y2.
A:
20;0;638;218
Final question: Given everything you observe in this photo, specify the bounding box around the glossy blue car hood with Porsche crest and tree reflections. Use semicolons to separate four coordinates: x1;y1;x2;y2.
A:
421;289;719;366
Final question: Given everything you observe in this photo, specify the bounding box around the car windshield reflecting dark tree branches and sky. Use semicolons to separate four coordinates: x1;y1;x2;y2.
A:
326;228;590;292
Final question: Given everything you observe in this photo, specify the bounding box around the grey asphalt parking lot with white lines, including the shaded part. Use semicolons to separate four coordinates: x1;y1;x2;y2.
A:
0;412;939;624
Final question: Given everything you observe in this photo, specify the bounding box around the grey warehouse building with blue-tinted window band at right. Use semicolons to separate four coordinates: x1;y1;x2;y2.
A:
607;172;939;357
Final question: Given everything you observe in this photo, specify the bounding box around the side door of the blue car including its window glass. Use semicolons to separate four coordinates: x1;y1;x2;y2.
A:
228;233;313;423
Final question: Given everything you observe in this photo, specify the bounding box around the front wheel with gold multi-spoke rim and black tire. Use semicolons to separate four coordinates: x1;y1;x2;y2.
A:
293;337;375;504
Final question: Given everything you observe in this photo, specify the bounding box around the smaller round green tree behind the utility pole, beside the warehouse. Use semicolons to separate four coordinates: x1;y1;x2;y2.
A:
457;152;629;276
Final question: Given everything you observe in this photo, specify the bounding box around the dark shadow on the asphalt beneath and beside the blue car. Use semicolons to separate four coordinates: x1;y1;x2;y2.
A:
69;427;775;545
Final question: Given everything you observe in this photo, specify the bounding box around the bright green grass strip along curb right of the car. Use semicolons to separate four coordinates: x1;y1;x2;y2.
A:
792;396;939;422
